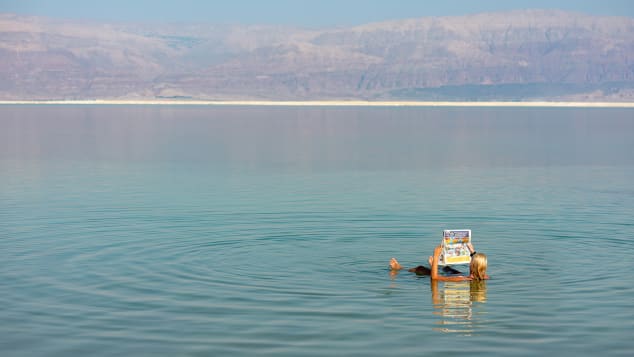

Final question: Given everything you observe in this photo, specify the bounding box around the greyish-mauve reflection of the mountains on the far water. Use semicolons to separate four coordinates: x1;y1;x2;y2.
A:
0;106;634;171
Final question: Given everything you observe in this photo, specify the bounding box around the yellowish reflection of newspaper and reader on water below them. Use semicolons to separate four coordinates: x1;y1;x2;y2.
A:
430;279;487;335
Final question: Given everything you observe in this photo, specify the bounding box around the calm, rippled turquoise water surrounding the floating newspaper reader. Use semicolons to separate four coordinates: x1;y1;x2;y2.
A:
0;106;634;356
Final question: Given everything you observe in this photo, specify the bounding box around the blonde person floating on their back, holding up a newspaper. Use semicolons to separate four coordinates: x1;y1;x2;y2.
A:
390;243;489;281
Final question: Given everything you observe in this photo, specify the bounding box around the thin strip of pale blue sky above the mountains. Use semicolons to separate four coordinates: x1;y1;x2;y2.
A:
0;0;634;27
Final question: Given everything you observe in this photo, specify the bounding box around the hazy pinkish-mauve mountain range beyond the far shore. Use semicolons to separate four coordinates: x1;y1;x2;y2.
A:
0;10;634;101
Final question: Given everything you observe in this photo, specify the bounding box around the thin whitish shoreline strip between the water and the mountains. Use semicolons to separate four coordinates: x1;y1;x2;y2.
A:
0;99;634;108
